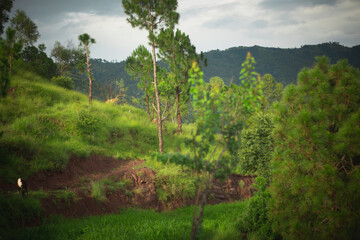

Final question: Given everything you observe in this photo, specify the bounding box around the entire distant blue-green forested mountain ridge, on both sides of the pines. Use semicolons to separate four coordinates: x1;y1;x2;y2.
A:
74;42;360;100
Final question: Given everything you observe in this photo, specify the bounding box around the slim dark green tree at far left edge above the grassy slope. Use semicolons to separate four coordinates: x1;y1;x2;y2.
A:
4;27;22;76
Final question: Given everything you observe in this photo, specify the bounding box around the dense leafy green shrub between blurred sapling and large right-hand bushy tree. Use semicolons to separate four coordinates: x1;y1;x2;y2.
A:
239;112;274;179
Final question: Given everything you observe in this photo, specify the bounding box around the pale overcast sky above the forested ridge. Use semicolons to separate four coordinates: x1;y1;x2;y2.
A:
7;0;360;61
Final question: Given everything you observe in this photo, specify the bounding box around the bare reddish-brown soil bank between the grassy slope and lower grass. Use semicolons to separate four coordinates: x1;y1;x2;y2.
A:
2;156;254;221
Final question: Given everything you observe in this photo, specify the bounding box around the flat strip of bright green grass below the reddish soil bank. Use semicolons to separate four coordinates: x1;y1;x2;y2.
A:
11;202;248;240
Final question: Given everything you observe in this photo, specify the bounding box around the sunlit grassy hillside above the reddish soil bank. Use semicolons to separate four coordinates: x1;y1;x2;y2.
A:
0;73;191;182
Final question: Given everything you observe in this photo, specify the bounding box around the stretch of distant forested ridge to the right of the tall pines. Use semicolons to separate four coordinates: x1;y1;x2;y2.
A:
203;42;360;86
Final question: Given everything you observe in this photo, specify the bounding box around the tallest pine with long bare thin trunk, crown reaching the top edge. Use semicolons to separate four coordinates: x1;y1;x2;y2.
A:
122;0;179;153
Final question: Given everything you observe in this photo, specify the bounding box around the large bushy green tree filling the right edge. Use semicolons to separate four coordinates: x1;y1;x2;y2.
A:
270;57;360;239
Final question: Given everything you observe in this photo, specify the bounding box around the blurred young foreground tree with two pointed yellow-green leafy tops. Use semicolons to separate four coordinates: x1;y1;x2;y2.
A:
158;53;262;239
